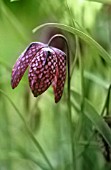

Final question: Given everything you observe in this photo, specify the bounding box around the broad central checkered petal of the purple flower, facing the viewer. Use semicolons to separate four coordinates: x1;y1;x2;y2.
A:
28;47;57;97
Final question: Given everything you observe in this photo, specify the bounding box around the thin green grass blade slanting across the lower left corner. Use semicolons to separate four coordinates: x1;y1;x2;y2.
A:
0;89;54;170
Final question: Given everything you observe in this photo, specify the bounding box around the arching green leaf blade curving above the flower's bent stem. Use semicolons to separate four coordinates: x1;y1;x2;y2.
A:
32;23;111;66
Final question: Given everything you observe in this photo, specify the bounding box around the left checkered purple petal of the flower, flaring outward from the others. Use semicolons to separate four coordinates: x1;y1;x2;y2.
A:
11;42;45;89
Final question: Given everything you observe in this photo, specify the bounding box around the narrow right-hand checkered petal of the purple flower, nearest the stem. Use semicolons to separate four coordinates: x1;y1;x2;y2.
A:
52;48;66;103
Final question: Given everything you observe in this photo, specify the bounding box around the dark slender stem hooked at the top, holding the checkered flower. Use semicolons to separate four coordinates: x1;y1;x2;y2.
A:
48;34;75;169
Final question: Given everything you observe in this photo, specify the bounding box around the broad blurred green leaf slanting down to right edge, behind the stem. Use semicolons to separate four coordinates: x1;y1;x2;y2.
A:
71;90;111;147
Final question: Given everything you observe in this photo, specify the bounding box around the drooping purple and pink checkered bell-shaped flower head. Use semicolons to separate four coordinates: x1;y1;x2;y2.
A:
11;42;66;103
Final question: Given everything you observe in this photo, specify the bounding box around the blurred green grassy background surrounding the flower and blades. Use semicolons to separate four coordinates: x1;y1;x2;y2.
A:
0;0;111;170
